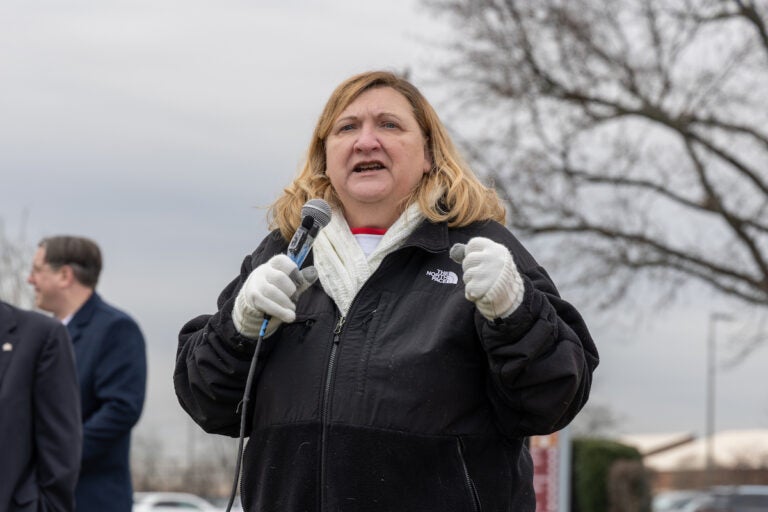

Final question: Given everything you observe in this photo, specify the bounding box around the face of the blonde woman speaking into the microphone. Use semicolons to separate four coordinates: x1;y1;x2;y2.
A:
325;87;432;228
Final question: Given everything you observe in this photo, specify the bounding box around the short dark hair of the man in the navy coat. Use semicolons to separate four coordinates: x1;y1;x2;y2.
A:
38;235;101;288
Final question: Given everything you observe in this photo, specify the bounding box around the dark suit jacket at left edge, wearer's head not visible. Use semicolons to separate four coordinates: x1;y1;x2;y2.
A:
0;302;82;512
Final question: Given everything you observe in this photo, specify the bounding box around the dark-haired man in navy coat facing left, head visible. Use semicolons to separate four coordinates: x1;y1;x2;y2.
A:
28;236;147;512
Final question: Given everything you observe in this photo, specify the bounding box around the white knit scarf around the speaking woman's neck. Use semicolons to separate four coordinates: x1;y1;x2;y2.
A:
312;204;424;316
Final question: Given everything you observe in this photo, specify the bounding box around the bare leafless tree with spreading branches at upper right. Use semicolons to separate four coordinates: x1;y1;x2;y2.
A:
426;0;768;352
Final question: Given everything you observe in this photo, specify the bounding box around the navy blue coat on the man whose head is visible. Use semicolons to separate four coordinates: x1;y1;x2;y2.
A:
67;293;147;512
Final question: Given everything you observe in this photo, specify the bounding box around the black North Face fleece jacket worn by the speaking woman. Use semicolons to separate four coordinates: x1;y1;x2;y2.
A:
174;221;598;512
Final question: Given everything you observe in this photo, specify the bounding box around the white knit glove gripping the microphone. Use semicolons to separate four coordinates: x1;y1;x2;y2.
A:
232;254;317;338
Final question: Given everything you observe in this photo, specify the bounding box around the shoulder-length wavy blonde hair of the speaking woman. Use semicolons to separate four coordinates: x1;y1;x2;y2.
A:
268;71;506;240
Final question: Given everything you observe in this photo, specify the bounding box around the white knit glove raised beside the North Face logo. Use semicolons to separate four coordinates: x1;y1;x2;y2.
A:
451;237;525;320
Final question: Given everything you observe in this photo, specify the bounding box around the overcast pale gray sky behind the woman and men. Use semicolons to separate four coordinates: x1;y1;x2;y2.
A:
0;0;768;462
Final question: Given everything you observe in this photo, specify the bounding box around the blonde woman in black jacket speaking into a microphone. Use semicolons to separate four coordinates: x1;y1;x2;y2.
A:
174;71;598;512
